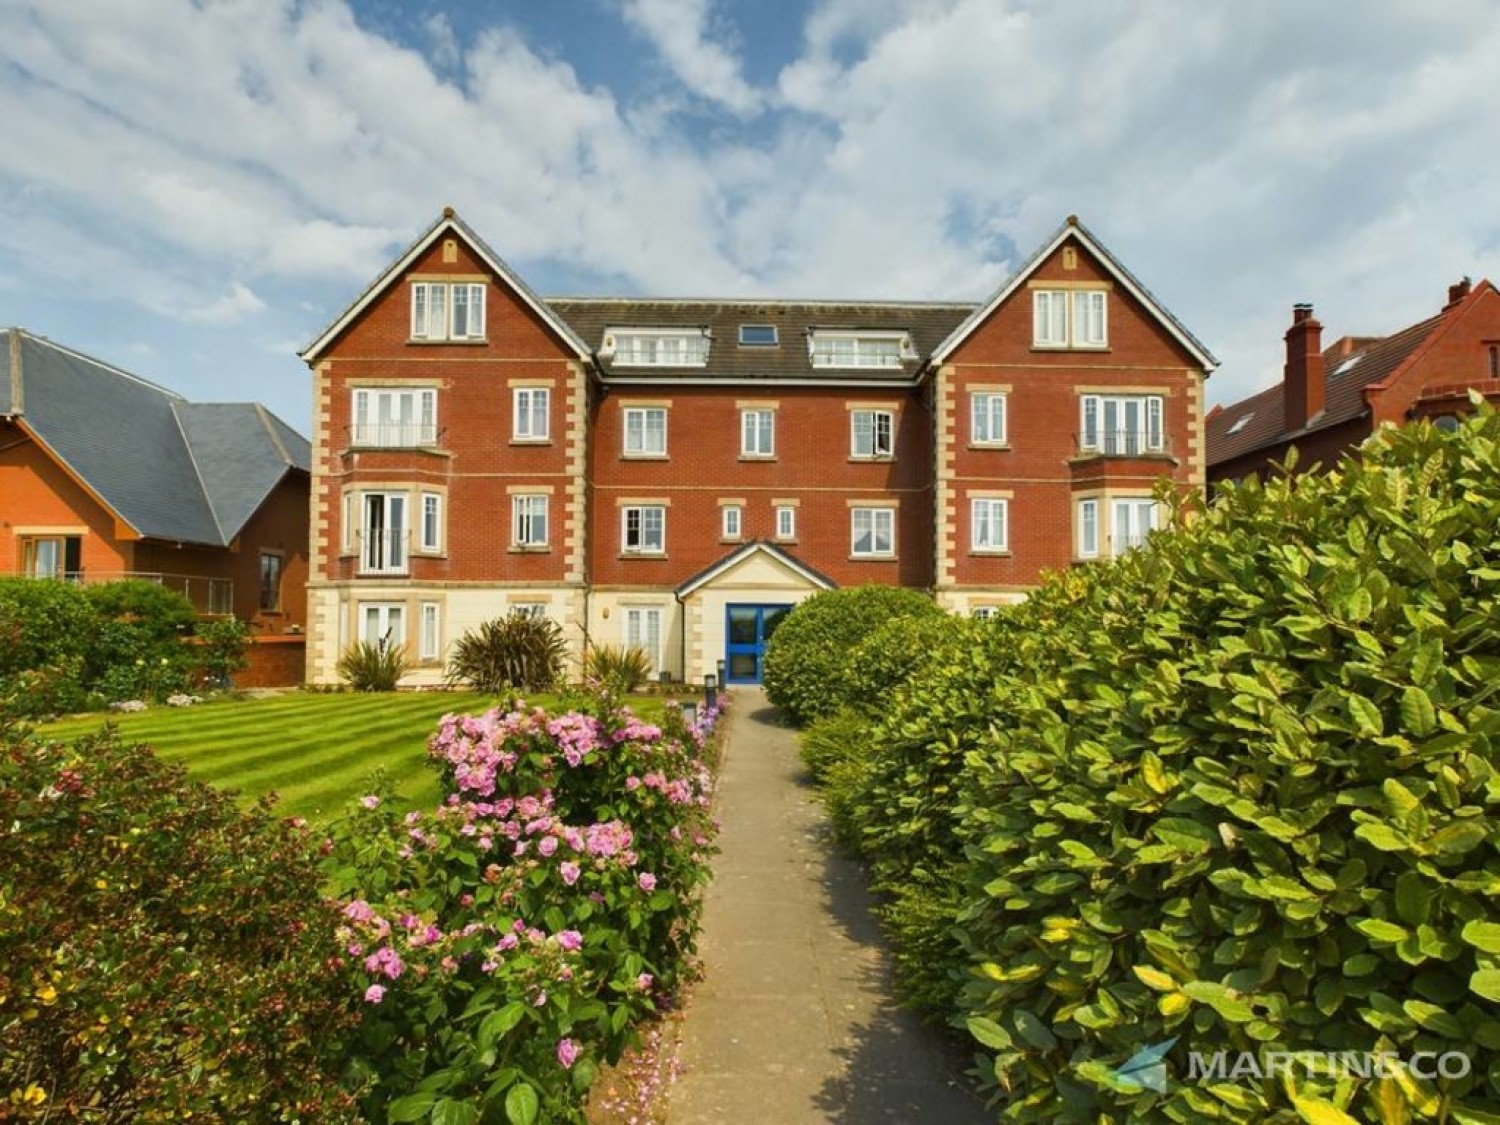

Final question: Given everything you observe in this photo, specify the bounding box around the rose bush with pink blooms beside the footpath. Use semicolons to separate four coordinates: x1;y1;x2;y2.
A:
327;704;719;1122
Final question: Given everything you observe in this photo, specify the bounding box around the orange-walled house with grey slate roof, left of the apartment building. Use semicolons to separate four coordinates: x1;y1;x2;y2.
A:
0;329;309;642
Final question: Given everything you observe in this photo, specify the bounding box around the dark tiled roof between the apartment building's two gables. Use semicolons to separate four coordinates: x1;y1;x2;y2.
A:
546;297;975;383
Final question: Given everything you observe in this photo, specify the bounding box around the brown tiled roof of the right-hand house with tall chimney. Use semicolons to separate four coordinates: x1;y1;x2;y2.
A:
1203;312;1446;465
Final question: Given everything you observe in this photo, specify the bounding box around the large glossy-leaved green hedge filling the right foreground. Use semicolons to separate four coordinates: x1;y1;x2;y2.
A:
828;411;1500;1122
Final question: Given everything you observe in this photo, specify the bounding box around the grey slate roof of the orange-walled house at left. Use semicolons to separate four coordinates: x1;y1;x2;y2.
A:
0;329;312;546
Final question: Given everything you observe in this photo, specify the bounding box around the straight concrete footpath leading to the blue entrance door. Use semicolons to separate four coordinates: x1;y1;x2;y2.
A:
668;689;993;1125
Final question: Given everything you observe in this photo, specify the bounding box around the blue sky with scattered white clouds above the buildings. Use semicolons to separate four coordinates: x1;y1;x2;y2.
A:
0;0;1500;432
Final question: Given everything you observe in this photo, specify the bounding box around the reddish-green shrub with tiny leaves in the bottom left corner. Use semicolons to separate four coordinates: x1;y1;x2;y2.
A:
0;728;354;1122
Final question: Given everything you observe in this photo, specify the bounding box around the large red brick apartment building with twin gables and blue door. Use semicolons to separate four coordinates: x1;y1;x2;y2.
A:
303;210;1215;684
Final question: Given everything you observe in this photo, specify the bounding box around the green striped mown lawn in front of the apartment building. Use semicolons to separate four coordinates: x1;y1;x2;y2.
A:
39;692;662;821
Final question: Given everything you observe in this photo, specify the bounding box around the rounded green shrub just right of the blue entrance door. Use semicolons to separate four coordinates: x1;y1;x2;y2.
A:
764;585;942;725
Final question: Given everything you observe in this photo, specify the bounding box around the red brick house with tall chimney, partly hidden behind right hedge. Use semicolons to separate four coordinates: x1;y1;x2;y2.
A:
1208;278;1500;482
